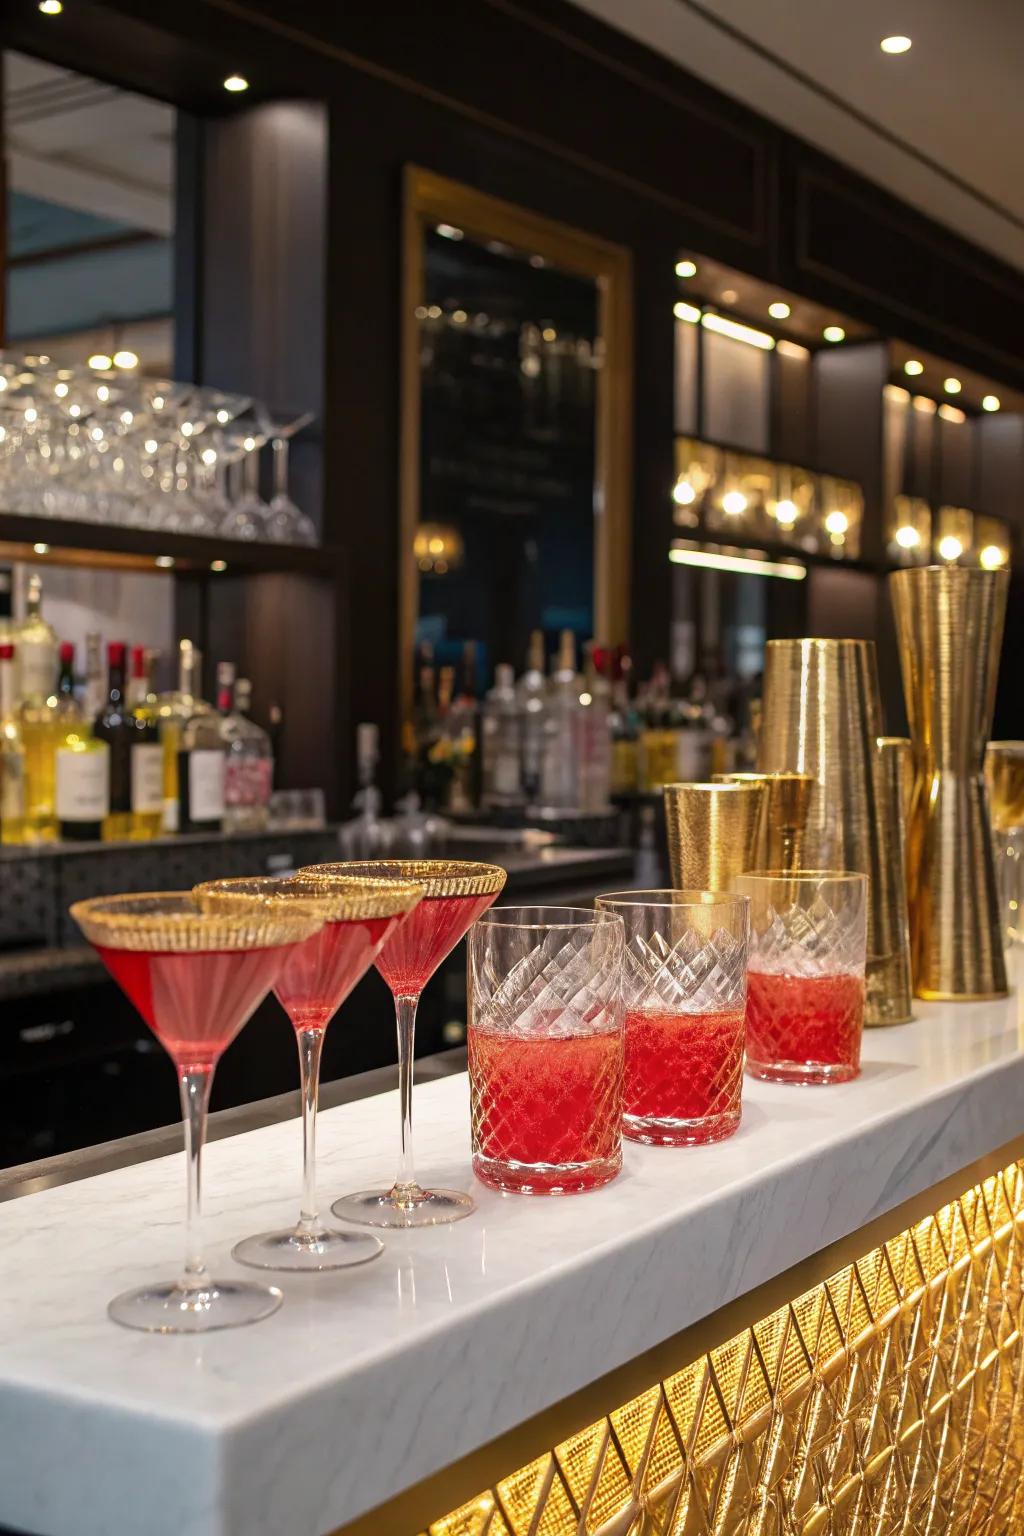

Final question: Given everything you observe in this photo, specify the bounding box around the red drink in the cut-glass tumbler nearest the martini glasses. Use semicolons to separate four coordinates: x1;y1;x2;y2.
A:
468;1028;623;1195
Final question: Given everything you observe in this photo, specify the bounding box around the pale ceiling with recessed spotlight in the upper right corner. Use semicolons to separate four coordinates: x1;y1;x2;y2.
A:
576;0;1024;269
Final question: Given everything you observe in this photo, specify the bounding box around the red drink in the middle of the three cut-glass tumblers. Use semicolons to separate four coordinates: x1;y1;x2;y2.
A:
622;1009;743;1146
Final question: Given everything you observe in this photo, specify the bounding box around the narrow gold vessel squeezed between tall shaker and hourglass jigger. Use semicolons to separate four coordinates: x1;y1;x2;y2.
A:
866;736;913;1025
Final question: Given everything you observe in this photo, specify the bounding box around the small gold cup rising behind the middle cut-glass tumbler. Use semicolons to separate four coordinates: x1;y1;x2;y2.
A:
665;782;766;891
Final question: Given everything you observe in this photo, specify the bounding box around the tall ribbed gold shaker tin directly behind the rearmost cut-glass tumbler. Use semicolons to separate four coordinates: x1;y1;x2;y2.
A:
757;639;907;1025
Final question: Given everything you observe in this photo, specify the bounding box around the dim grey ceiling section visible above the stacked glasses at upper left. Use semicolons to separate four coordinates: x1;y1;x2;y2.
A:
3;52;175;239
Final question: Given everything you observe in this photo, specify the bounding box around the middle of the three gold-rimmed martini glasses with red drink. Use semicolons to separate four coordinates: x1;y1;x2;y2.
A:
193;876;424;1273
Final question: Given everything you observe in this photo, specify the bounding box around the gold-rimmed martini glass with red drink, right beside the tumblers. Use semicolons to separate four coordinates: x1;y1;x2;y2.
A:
299;859;507;1227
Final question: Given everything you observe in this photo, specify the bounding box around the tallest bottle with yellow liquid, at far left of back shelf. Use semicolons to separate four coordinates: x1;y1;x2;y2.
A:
14;574;57;842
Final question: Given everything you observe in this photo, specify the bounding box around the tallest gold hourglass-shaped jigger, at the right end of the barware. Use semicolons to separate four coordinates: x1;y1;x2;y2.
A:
889;565;1010;998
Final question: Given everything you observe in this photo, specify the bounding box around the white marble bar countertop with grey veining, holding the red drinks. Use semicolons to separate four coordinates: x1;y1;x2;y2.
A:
0;998;1024;1536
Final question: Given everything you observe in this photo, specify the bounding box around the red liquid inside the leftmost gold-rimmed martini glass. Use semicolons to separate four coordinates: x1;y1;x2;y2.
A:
95;945;289;1072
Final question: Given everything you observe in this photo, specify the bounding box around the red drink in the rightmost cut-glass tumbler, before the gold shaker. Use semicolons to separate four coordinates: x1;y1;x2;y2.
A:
746;971;864;1083
